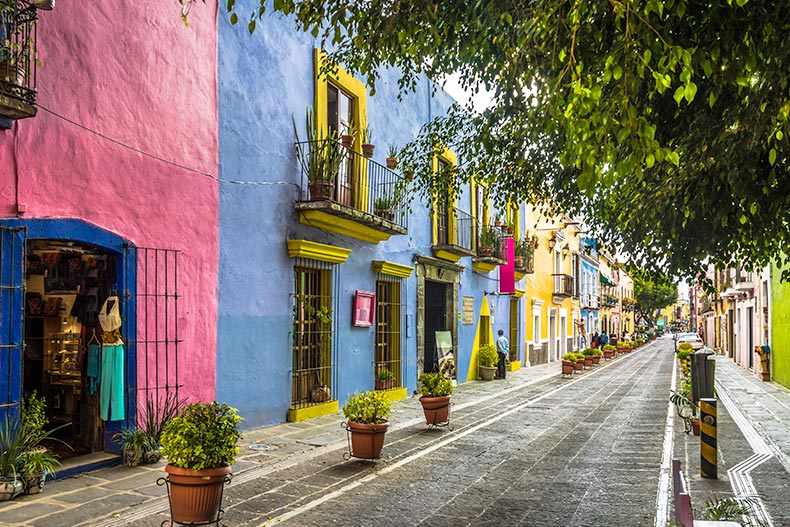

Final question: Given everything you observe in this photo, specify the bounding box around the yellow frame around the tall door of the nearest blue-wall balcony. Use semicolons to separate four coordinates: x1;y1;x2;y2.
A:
313;48;368;210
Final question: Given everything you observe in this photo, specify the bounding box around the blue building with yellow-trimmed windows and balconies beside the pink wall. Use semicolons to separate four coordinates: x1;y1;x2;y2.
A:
217;12;526;427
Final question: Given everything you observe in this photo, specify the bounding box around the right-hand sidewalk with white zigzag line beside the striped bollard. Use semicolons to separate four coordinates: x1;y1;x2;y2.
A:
674;356;790;526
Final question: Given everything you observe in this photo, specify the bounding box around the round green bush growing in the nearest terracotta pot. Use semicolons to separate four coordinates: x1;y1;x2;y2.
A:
161;401;243;470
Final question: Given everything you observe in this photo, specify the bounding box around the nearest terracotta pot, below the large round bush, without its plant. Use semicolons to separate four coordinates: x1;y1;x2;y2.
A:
165;465;231;523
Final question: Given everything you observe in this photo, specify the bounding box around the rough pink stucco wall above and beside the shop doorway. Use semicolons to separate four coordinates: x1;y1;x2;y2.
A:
0;4;218;399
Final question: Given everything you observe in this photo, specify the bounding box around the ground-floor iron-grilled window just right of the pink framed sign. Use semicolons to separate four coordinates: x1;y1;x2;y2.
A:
375;275;402;387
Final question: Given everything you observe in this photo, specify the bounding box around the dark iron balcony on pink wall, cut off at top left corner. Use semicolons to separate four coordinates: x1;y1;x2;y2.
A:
0;0;37;119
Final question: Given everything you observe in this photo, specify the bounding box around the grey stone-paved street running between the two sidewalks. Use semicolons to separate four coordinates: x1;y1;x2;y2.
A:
198;342;673;527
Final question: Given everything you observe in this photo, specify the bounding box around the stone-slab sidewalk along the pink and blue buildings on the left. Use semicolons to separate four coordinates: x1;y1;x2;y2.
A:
0;362;560;527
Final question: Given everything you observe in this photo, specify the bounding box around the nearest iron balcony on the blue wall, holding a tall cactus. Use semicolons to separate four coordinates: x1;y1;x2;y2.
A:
295;140;409;242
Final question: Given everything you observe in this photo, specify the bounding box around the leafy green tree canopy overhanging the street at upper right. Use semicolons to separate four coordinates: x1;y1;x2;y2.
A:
190;0;790;276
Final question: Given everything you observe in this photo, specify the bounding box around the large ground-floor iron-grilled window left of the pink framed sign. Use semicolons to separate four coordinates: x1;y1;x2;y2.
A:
291;259;336;408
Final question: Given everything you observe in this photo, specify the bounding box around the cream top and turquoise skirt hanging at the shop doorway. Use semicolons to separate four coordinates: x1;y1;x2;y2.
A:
99;296;124;421
